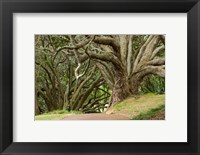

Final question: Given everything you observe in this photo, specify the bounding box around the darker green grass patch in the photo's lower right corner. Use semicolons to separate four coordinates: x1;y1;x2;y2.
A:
132;105;165;120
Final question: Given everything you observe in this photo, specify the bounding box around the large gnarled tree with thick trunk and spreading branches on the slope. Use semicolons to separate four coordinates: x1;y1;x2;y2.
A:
61;35;165;104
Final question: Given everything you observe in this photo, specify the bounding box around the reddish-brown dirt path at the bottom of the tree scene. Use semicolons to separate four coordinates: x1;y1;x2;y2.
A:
63;114;129;120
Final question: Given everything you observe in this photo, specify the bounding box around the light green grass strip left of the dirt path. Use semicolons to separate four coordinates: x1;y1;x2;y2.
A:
35;110;81;120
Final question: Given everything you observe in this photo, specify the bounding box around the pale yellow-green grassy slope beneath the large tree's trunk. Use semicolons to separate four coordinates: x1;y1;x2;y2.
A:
111;93;165;119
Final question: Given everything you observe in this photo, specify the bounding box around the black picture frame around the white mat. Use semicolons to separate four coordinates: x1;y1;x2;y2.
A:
0;0;200;155
